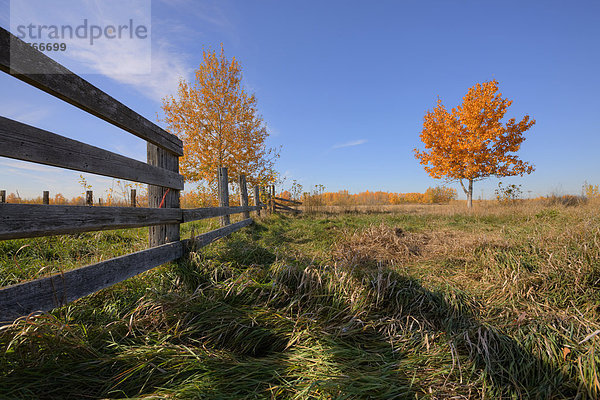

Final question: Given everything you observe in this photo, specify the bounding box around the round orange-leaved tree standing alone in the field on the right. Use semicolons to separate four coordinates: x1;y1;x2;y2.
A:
414;80;535;208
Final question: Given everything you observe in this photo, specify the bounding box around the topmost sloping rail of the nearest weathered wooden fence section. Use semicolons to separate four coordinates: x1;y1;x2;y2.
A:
0;28;183;155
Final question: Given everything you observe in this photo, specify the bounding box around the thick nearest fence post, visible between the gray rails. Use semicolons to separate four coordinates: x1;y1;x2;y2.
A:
146;143;180;247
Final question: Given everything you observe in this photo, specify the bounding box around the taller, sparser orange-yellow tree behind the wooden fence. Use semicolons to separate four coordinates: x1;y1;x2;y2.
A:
162;46;279;190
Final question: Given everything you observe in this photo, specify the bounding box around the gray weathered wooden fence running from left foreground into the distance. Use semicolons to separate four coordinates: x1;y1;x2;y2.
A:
0;28;261;323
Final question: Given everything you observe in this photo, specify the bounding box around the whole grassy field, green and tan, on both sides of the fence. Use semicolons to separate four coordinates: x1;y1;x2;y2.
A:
0;204;600;399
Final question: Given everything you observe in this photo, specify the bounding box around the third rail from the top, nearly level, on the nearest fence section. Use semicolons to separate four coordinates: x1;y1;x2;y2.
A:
0;204;181;240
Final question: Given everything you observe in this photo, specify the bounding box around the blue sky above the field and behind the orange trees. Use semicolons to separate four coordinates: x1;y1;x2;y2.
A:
0;0;600;198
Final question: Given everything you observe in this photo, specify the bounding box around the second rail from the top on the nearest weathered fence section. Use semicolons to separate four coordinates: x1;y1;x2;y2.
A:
0;117;183;189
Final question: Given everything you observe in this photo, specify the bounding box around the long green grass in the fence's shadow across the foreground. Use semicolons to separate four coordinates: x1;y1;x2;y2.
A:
0;230;584;399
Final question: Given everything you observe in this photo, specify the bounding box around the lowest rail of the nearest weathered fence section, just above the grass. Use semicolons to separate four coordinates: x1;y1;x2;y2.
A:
0;242;185;323
